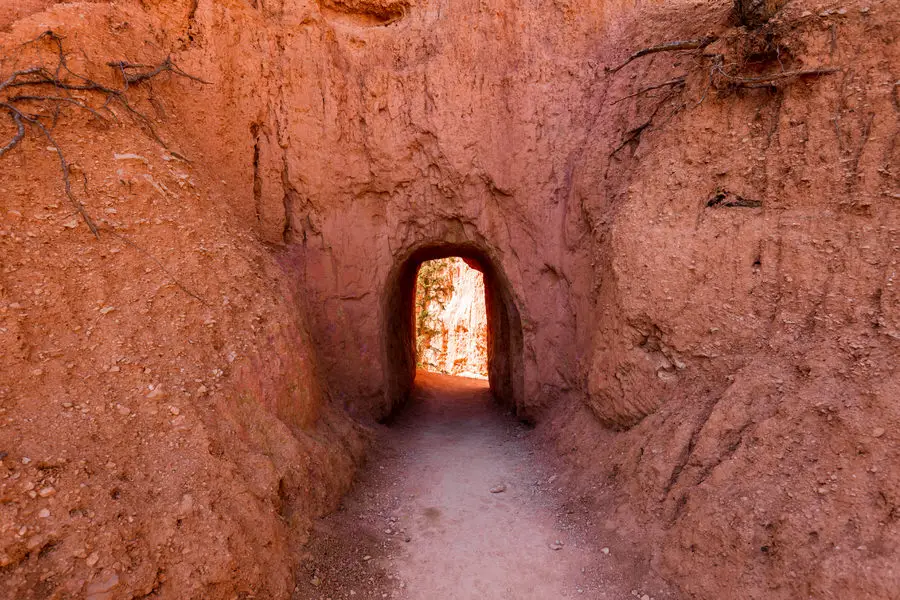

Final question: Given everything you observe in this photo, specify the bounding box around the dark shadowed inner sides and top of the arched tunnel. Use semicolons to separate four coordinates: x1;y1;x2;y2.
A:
382;243;524;408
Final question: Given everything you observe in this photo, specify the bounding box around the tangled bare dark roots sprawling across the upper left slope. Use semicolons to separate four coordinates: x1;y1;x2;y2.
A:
0;30;207;237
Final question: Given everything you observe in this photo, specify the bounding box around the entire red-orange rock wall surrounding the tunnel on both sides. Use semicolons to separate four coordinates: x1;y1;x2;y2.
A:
0;0;900;598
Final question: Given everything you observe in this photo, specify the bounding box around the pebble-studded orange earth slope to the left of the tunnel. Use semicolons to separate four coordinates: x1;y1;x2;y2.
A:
0;2;363;600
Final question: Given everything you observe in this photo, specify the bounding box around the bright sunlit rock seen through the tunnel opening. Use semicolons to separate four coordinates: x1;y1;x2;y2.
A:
415;257;488;379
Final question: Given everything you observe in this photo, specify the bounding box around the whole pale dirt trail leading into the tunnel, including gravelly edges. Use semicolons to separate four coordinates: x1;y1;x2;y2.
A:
295;373;673;600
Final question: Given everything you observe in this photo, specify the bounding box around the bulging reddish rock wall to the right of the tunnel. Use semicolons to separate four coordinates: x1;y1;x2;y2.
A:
572;2;900;598
